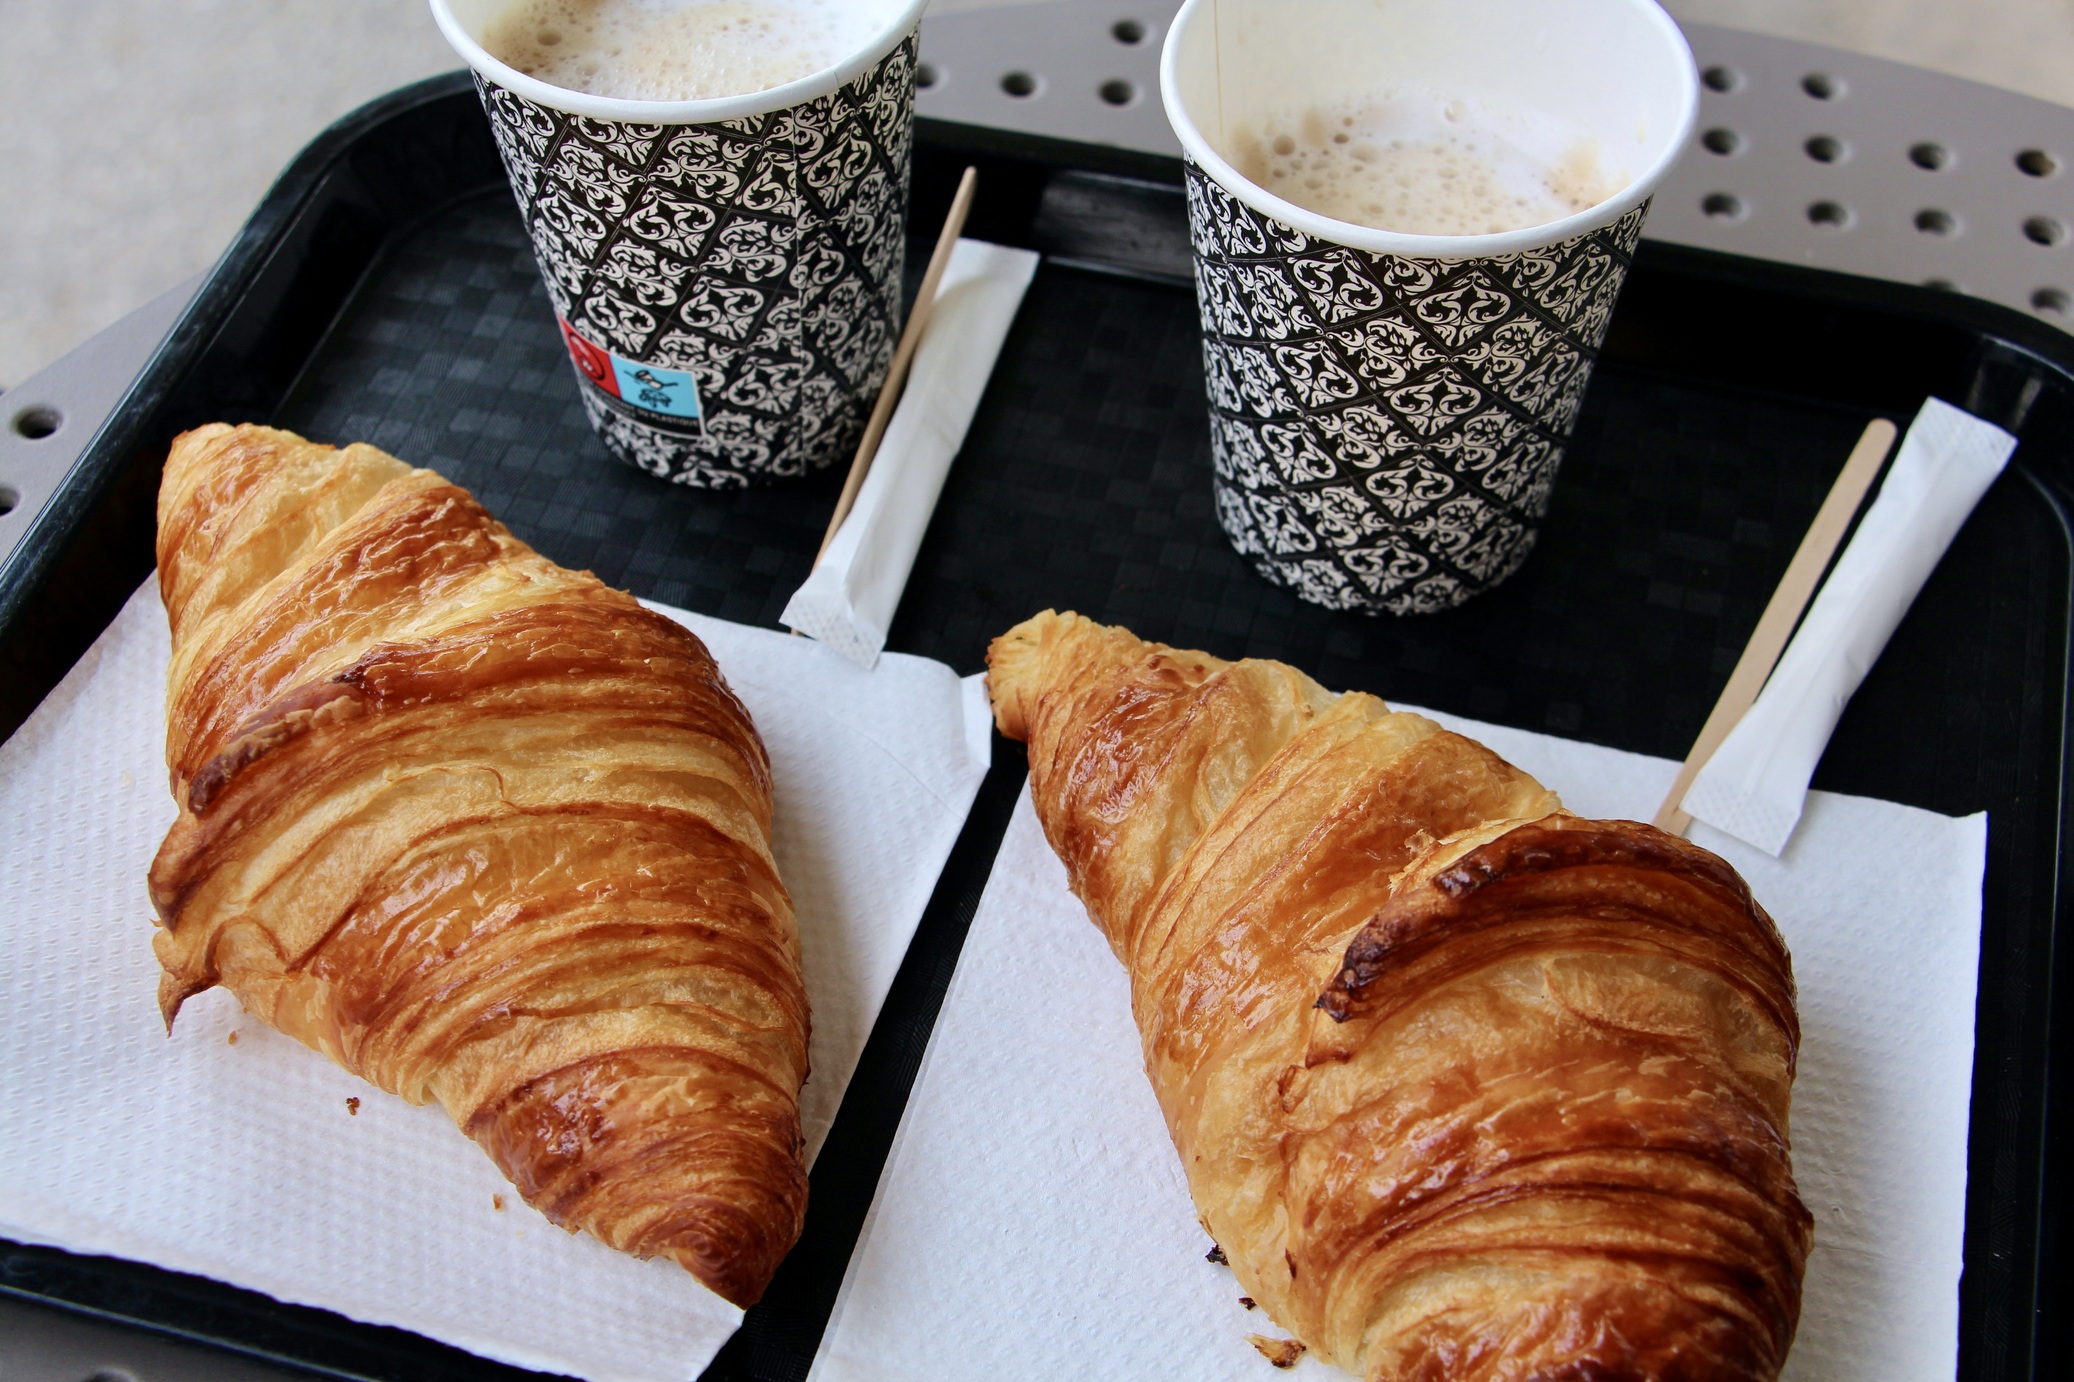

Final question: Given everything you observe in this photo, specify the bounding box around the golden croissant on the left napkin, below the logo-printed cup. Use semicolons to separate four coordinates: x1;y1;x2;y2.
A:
151;425;807;1305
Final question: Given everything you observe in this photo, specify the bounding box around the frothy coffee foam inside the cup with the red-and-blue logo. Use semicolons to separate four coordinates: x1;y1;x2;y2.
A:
483;0;886;102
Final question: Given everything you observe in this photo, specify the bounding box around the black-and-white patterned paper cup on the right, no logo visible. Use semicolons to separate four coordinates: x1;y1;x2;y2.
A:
1161;0;1699;614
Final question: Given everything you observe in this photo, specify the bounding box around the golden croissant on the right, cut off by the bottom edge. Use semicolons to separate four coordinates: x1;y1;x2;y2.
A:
987;612;1811;1382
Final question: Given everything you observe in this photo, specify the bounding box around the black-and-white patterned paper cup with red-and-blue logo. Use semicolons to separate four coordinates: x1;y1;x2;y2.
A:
431;0;927;490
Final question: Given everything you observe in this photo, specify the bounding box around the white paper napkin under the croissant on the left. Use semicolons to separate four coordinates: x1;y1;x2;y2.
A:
0;581;991;1382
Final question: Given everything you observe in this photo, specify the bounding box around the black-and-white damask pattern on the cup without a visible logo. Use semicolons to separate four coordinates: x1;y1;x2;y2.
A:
1186;162;1649;614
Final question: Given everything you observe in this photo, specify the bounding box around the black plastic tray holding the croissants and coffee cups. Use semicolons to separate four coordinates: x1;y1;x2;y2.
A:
0;75;2074;1382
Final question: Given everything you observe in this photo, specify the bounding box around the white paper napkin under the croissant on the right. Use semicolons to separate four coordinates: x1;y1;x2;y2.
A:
813;716;1987;1382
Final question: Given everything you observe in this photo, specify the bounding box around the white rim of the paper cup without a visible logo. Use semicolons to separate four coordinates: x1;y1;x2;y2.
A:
1161;0;1699;259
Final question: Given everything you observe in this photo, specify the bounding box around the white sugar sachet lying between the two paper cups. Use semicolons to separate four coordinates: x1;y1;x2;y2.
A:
782;241;1039;666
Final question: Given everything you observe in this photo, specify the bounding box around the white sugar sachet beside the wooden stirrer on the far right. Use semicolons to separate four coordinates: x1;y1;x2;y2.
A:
1682;398;2016;855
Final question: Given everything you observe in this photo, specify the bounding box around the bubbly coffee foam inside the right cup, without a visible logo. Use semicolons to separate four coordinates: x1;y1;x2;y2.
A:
1228;89;1628;234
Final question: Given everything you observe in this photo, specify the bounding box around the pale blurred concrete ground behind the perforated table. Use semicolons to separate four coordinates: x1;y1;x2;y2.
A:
0;0;2074;386
